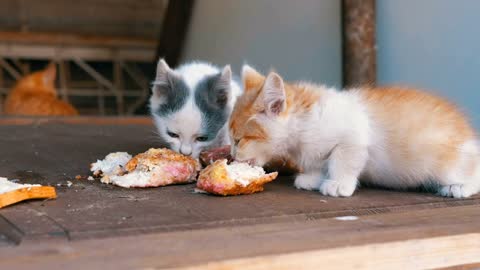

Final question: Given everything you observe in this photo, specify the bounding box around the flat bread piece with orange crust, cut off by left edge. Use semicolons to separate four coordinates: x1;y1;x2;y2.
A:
0;177;57;208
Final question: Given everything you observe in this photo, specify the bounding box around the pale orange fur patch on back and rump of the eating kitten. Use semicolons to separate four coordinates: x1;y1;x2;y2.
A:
359;87;476;177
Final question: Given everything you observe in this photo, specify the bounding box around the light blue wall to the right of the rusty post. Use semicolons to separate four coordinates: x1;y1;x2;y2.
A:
377;0;480;130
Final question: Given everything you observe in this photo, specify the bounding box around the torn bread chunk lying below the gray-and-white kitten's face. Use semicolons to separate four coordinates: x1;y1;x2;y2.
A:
91;148;200;188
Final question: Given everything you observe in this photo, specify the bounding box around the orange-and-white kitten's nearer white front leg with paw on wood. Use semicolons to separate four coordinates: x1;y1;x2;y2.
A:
320;145;368;197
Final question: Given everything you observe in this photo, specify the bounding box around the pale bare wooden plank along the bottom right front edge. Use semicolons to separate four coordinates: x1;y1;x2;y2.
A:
179;233;480;270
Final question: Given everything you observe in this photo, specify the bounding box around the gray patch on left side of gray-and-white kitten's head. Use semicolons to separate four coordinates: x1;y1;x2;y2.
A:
151;77;189;116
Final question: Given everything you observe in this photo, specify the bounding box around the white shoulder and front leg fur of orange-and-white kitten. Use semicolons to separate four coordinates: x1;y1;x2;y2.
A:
289;89;370;197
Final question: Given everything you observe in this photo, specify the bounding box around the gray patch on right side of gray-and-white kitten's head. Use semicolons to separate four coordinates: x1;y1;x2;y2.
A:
195;73;230;141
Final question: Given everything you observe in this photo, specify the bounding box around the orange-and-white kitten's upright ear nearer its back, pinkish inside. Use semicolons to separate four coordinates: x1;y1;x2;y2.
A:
262;72;287;116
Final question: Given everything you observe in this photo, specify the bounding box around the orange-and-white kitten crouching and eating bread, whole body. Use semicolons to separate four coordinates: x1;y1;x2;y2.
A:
229;66;480;198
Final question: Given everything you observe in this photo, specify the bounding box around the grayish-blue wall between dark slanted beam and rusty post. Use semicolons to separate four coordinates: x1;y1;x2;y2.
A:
183;0;342;86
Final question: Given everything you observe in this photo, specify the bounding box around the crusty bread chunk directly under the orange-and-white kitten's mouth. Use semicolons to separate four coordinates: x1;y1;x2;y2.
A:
197;159;278;196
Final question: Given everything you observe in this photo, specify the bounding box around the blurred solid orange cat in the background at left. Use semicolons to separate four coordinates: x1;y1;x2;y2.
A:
4;63;78;116
